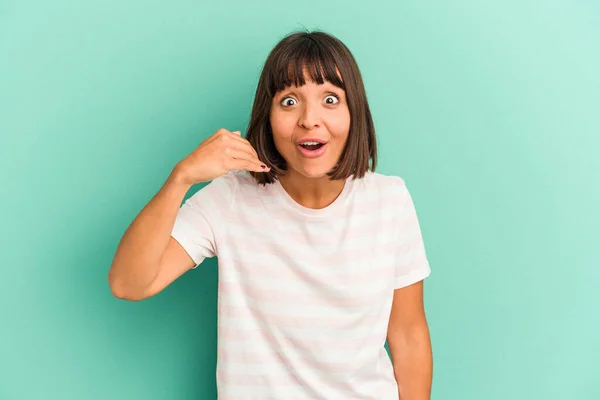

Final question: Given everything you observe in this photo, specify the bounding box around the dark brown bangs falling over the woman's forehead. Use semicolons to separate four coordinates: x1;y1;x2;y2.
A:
268;39;346;97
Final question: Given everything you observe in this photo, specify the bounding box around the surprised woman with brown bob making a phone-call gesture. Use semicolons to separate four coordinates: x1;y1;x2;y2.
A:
109;32;432;400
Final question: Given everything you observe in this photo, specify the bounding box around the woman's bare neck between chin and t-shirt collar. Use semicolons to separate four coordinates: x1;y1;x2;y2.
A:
279;171;346;209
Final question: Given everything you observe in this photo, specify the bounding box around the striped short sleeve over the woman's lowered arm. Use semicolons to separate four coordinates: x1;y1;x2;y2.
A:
394;181;431;289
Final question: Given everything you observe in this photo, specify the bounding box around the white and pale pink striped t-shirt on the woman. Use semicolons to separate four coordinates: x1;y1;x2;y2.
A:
172;171;430;400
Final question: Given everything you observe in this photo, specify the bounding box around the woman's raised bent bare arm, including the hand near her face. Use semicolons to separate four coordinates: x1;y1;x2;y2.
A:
108;129;269;301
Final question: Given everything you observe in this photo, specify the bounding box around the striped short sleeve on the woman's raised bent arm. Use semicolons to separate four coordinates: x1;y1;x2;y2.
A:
171;172;236;268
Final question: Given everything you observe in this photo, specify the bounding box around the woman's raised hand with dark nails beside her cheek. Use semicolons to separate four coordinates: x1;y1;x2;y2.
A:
175;128;270;185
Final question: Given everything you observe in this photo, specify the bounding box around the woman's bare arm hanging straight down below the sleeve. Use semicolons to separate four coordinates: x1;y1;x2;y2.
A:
387;281;433;400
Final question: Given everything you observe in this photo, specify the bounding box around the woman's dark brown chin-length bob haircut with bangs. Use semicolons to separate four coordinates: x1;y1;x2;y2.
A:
246;31;377;185
